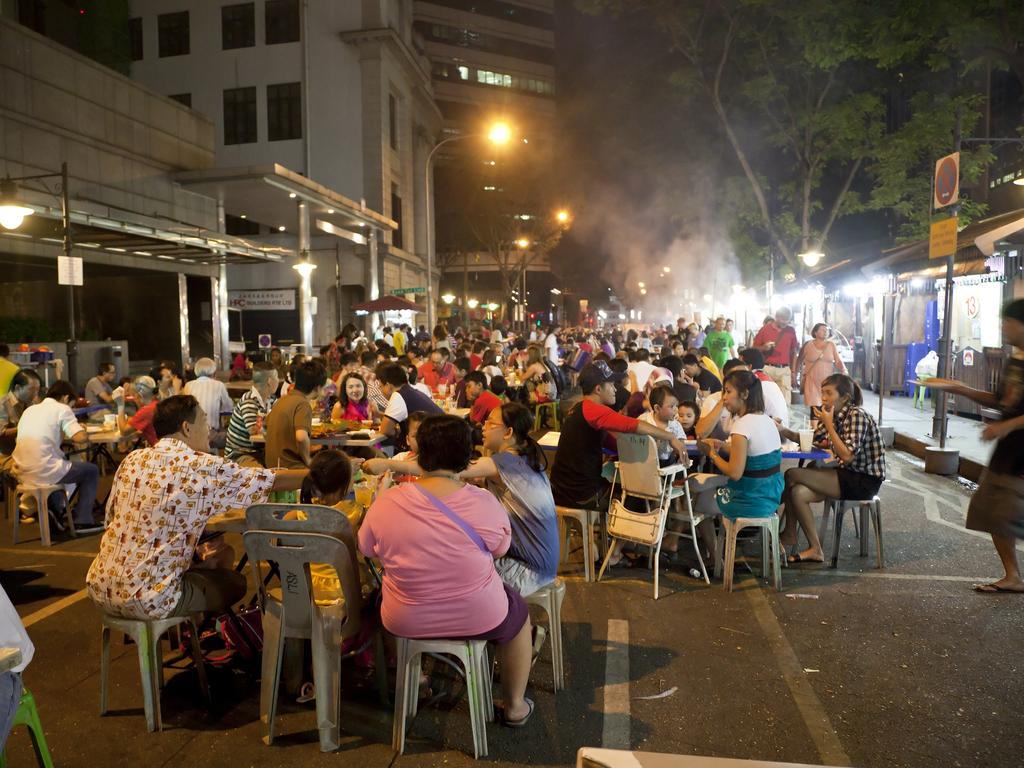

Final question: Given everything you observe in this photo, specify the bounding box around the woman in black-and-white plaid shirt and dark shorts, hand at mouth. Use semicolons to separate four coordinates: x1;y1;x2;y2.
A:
779;374;886;562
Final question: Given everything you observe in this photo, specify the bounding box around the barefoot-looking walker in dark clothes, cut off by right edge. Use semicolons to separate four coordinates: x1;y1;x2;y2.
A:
928;299;1024;594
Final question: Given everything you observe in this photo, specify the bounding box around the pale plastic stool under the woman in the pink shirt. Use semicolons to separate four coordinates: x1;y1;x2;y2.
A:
391;637;495;758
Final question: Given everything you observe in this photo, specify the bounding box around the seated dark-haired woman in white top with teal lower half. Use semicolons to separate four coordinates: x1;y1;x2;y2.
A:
703;371;784;519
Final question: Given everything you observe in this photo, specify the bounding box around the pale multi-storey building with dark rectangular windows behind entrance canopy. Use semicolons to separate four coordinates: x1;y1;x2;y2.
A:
129;0;441;345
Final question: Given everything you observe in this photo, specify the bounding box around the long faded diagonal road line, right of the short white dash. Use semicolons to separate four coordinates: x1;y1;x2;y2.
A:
743;587;852;765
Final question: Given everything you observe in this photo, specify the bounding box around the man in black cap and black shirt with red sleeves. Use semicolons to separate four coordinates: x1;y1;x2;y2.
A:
551;360;687;509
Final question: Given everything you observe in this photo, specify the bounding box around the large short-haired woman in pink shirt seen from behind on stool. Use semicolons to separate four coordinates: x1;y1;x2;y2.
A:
358;416;534;727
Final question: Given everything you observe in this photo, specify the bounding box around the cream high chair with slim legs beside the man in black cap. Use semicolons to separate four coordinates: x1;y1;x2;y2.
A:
597;434;711;600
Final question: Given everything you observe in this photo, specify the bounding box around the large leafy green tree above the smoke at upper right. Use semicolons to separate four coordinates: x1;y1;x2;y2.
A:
583;0;990;272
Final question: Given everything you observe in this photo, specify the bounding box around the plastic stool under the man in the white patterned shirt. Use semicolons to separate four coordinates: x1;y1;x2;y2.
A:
99;613;210;731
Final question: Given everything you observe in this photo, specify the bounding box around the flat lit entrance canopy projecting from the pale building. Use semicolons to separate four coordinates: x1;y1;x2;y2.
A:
175;163;398;232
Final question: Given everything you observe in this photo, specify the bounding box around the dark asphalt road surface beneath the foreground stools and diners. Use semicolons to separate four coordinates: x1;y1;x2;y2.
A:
0;454;1024;768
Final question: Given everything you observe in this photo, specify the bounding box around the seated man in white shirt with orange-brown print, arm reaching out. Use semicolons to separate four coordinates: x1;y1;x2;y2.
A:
86;395;308;618
